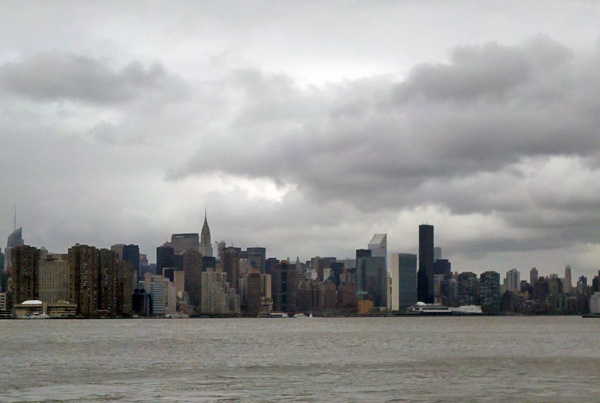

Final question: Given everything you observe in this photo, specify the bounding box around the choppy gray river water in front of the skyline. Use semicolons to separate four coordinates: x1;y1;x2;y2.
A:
0;317;600;402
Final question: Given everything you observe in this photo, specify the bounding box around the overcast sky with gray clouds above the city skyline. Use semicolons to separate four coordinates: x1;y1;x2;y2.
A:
0;0;600;278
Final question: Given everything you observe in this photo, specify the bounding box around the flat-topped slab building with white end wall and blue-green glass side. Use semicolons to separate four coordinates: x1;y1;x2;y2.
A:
391;253;417;311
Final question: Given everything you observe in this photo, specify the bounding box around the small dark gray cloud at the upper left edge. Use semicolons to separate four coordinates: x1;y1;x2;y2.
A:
0;52;182;104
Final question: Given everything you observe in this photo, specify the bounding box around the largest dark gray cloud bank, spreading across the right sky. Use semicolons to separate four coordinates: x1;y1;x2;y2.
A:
174;37;600;210
